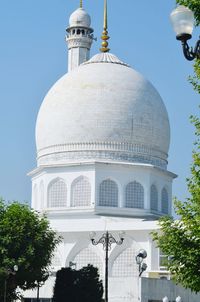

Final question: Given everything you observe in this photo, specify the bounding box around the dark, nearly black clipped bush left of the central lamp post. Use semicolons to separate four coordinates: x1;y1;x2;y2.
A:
53;265;103;302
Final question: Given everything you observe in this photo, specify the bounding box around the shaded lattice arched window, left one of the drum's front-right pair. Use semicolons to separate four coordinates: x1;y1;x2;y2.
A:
99;179;118;207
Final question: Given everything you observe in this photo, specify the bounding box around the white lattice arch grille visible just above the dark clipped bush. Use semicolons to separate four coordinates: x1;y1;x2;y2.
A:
72;248;104;279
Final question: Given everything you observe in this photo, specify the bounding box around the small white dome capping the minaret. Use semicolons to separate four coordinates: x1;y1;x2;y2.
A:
69;8;91;27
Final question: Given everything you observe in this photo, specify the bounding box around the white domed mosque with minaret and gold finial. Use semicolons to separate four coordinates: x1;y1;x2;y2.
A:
25;1;200;302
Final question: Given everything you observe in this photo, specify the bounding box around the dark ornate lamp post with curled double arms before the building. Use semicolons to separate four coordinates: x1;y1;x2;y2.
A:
90;231;124;302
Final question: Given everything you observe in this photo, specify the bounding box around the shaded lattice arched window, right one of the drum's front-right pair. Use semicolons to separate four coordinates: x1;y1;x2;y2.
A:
125;181;144;209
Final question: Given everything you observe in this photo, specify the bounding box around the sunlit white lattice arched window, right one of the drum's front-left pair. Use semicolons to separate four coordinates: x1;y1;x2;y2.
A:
71;176;91;207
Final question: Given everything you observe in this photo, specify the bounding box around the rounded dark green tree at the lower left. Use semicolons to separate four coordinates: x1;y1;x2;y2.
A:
0;199;60;301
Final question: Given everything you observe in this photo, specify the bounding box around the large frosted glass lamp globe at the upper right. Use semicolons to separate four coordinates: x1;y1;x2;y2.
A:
170;5;194;40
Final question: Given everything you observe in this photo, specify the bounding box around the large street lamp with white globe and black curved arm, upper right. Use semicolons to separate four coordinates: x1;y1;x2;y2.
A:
170;5;200;61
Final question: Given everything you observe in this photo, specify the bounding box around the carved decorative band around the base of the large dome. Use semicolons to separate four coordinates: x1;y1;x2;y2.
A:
37;142;167;169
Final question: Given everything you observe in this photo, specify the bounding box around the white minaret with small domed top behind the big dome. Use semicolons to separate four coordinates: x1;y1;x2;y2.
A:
66;0;93;71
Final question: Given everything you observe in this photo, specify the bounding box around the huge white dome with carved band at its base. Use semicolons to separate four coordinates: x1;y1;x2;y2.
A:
36;54;170;168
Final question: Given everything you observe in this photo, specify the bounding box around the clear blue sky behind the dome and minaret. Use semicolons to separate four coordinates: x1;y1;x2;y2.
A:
0;0;200;206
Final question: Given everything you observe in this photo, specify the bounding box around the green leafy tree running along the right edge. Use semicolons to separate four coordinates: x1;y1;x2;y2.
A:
153;0;200;292
